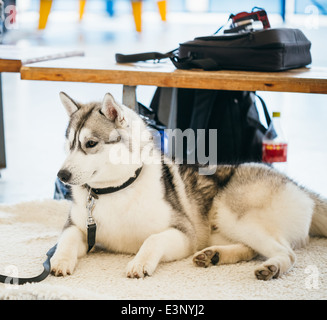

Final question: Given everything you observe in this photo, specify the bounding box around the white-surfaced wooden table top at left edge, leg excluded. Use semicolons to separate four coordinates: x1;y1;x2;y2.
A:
0;45;84;72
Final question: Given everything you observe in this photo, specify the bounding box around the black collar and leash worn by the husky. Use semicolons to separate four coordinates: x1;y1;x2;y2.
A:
0;167;142;285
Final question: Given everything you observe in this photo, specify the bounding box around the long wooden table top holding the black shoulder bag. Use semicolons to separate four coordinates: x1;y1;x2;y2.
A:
21;57;327;94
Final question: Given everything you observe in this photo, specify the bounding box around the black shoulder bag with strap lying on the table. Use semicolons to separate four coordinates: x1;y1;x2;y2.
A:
116;28;311;71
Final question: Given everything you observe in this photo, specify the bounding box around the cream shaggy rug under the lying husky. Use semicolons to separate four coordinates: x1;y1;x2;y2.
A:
0;200;327;300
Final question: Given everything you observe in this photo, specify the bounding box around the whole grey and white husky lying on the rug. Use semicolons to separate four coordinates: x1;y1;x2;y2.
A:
51;93;327;280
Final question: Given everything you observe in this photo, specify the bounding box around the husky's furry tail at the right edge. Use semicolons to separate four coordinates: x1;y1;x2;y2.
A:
309;192;327;237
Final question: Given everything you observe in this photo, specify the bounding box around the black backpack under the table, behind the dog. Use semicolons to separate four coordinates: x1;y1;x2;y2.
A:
151;88;271;164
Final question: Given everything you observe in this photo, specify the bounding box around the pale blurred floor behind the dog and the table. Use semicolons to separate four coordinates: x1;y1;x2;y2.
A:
0;13;327;202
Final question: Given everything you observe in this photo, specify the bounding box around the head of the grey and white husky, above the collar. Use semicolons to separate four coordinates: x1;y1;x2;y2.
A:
58;92;151;188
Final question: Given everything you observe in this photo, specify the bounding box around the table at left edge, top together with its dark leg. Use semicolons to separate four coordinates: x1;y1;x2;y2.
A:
0;45;84;169
